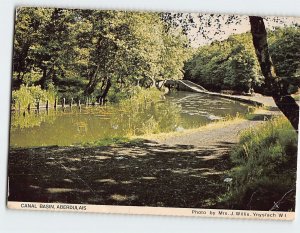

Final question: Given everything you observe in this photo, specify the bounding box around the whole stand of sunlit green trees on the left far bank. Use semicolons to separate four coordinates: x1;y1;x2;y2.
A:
13;8;189;104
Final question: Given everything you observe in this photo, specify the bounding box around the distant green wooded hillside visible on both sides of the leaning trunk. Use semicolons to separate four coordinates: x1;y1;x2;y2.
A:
185;27;300;93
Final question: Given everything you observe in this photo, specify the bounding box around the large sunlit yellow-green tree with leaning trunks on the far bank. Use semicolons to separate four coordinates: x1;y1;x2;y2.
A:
78;11;189;99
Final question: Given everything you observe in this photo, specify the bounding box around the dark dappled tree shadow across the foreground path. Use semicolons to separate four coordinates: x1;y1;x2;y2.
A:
8;140;232;208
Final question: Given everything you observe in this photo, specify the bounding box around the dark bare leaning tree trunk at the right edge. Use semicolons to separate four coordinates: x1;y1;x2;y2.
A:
249;16;299;133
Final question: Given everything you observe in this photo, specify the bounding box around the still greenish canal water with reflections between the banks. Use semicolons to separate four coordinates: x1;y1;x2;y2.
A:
10;92;248;147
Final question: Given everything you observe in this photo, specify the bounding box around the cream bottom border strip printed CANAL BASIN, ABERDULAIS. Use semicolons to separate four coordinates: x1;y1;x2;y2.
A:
7;201;295;221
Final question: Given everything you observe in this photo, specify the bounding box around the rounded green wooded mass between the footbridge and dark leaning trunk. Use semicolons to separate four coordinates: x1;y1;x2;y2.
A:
184;33;260;93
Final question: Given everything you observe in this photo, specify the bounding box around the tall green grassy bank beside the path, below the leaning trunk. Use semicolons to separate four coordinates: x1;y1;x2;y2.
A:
226;117;297;210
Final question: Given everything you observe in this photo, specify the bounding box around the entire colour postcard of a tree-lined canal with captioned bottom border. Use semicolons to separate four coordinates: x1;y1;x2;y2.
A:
7;7;300;220
